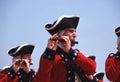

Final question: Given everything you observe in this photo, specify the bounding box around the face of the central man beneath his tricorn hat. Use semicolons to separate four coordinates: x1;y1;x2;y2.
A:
63;28;77;46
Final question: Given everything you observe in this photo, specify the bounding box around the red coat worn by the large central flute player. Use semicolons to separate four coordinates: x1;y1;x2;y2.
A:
34;49;96;82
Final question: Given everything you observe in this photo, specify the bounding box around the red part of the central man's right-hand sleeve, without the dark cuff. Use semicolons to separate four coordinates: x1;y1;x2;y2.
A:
75;52;96;75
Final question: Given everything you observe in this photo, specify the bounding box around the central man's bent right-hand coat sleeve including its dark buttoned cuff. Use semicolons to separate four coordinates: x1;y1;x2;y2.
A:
63;48;96;75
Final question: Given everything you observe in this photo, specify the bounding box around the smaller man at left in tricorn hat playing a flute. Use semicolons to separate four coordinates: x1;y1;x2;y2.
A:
0;44;35;82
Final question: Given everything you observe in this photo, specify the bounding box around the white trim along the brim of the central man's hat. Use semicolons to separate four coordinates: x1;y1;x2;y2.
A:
45;15;80;30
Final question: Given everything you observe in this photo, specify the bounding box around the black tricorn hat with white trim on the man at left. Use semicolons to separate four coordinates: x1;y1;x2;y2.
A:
8;44;35;57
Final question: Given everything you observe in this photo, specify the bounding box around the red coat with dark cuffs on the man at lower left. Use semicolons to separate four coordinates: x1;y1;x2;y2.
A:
0;68;35;82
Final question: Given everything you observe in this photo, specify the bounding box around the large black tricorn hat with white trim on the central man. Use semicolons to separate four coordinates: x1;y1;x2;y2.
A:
45;15;80;35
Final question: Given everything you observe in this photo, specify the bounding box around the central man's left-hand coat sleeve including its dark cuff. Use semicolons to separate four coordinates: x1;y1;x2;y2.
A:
32;49;55;82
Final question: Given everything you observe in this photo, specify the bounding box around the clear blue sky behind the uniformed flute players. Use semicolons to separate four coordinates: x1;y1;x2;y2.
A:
0;0;120;82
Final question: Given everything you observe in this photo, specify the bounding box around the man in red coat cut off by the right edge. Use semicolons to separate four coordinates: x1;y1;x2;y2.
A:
105;27;120;82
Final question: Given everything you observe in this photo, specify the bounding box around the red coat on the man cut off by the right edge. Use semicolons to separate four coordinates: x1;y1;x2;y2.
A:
105;54;120;82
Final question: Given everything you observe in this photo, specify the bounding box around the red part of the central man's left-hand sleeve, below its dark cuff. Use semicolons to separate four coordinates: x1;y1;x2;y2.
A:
32;56;53;82
